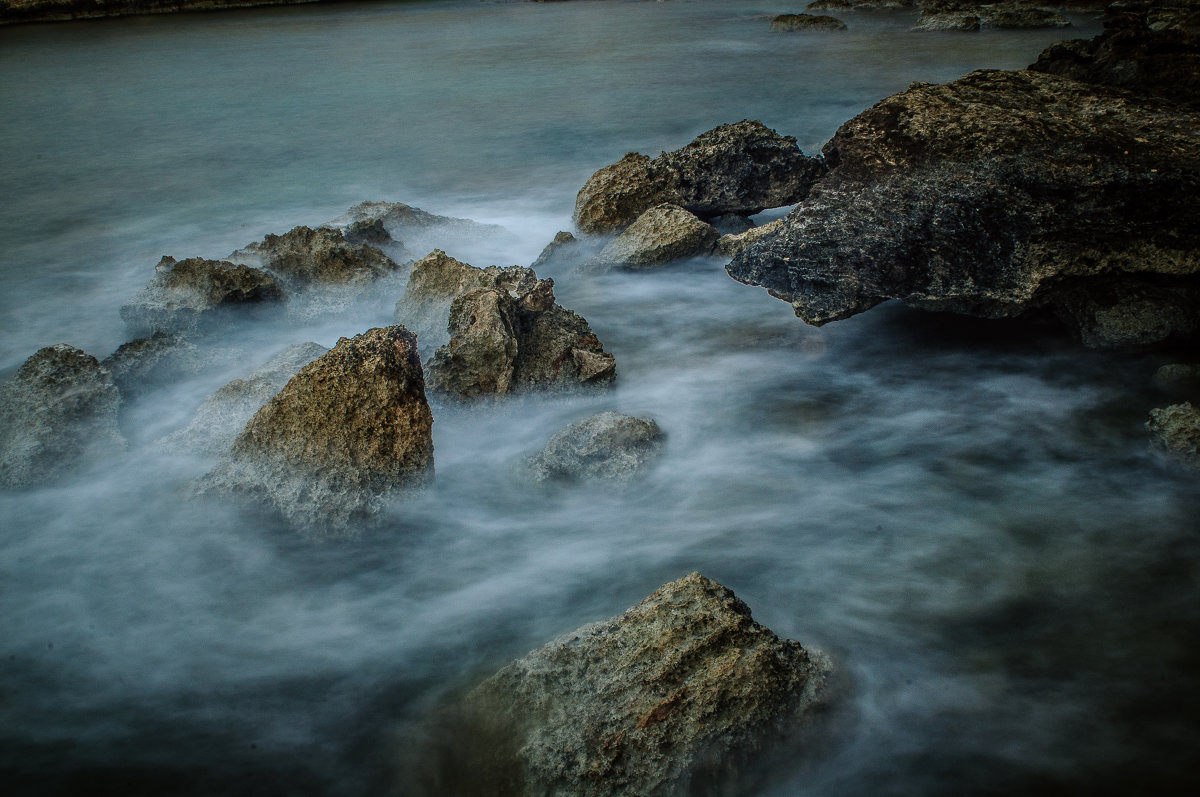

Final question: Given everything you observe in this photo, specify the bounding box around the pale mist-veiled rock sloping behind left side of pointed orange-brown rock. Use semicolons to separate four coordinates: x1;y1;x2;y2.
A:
161;343;329;456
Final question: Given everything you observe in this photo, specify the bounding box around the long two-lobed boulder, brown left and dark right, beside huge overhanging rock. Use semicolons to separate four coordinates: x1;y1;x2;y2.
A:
575;120;826;233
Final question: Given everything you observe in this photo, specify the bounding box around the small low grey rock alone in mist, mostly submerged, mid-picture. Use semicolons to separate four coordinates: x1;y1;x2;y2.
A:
524;412;666;481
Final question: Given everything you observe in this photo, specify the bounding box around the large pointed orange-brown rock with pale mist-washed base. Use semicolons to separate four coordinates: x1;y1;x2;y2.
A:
199;326;433;537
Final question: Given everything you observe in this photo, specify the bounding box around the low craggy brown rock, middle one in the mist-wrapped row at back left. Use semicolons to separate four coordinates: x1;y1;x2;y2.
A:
229;227;398;287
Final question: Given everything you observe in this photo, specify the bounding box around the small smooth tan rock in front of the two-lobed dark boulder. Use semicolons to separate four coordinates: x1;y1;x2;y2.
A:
590;204;720;269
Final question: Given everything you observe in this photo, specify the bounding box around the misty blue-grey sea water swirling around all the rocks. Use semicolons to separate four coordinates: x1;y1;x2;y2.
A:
0;0;1200;796
